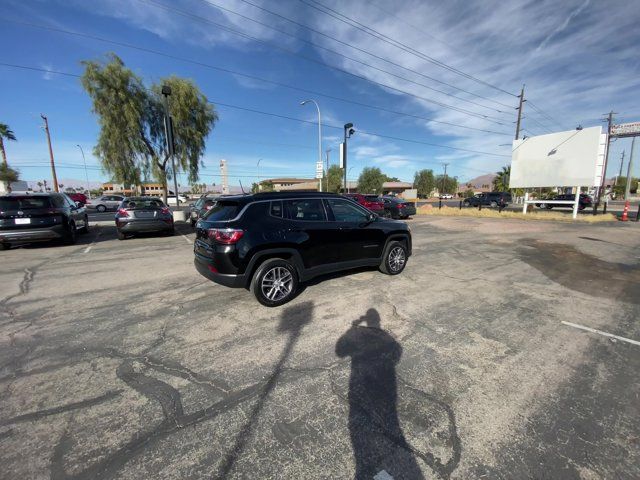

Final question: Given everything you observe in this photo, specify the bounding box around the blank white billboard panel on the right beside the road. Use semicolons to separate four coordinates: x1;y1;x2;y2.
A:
509;127;602;188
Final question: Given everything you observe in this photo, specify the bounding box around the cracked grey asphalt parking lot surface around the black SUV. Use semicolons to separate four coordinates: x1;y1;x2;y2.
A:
0;217;640;480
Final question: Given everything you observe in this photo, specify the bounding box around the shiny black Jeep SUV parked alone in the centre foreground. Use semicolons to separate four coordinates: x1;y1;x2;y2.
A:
194;192;411;307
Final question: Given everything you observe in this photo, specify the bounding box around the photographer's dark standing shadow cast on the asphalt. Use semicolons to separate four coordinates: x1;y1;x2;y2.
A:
336;308;424;480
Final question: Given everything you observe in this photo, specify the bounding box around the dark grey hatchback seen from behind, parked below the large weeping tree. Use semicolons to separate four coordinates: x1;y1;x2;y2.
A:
116;197;174;240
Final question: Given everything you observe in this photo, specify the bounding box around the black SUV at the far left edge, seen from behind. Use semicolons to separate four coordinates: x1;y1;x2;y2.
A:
0;193;89;250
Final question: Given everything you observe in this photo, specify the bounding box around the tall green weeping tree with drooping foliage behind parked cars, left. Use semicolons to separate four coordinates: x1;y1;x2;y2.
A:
81;54;218;200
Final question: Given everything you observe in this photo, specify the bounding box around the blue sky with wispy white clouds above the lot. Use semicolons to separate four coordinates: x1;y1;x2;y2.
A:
0;0;640;186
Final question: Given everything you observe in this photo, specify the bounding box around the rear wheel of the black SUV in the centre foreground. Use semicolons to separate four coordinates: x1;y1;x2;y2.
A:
251;258;298;307
